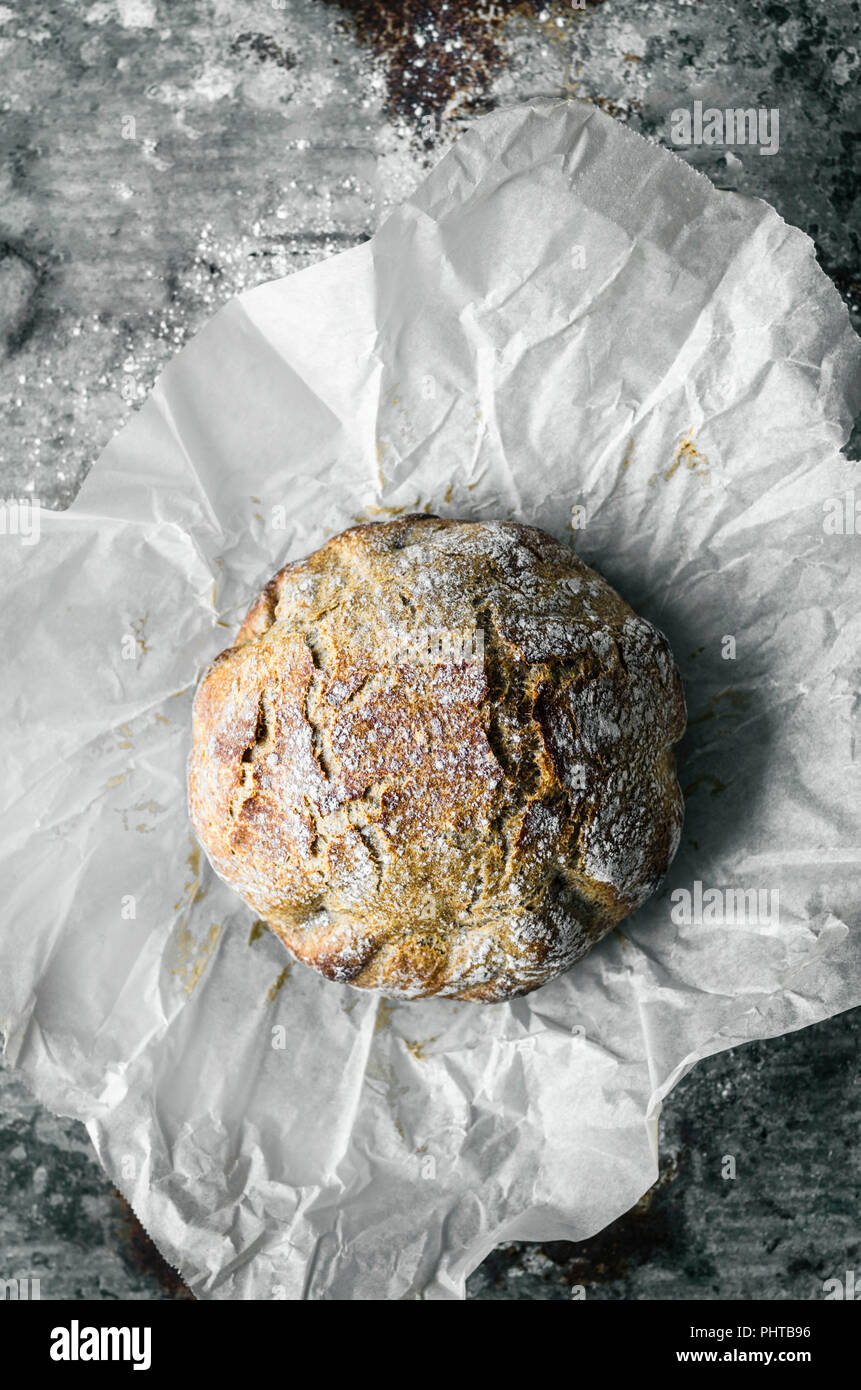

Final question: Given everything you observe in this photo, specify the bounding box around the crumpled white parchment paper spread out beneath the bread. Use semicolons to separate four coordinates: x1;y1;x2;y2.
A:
0;103;861;1300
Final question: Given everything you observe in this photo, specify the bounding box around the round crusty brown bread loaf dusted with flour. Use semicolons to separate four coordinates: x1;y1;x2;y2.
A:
189;514;686;1002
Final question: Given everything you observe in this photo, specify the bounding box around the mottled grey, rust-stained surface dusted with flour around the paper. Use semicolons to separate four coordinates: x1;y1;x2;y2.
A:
0;0;861;1300
